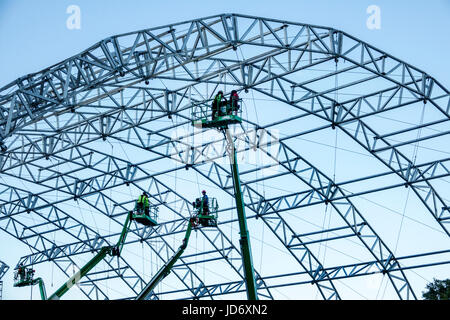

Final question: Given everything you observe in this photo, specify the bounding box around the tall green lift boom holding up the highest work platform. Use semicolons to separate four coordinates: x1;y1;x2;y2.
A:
225;129;258;300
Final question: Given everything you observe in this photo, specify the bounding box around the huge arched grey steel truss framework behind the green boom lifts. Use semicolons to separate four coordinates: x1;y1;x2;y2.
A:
0;14;450;299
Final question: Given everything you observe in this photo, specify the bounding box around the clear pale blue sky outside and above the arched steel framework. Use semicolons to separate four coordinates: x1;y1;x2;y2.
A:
0;0;450;299
